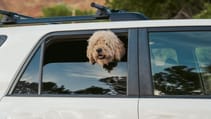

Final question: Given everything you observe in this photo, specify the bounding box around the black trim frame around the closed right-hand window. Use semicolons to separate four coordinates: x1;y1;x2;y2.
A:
142;26;211;99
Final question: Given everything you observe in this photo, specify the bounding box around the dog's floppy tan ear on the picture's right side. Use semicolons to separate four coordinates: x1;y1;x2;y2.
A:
114;40;125;61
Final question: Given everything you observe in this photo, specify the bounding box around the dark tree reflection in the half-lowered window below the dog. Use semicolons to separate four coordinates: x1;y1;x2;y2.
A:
43;77;126;95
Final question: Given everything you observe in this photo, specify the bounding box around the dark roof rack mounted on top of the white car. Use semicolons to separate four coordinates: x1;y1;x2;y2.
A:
0;2;148;24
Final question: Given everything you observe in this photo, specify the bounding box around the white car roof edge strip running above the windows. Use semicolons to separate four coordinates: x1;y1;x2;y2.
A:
0;19;211;33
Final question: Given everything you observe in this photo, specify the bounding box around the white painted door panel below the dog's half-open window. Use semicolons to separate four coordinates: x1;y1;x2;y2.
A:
0;97;138;119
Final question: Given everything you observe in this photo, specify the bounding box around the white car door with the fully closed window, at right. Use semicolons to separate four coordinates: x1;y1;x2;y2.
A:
139;27;211;119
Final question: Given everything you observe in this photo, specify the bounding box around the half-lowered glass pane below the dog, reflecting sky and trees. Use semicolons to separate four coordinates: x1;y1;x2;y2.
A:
42;62;127;95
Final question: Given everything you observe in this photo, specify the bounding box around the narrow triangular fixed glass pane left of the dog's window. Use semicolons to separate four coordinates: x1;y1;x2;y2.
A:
13;48;41;95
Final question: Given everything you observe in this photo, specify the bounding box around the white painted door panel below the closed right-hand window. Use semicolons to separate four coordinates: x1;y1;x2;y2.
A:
139;98;211;119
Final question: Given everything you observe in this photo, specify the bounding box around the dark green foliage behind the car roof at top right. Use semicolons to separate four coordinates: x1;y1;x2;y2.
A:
106;0;210;19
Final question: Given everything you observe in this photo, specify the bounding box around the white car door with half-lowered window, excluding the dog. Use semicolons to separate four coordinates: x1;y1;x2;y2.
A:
0;29;139;119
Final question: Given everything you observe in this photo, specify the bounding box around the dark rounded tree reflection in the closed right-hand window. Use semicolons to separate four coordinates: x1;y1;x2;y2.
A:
153;66;202;95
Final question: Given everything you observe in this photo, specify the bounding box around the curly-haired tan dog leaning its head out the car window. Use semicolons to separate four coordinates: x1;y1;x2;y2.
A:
87;30;125;72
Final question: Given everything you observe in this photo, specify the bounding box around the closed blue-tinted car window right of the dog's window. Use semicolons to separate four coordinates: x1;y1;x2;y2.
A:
149;32;211;95
